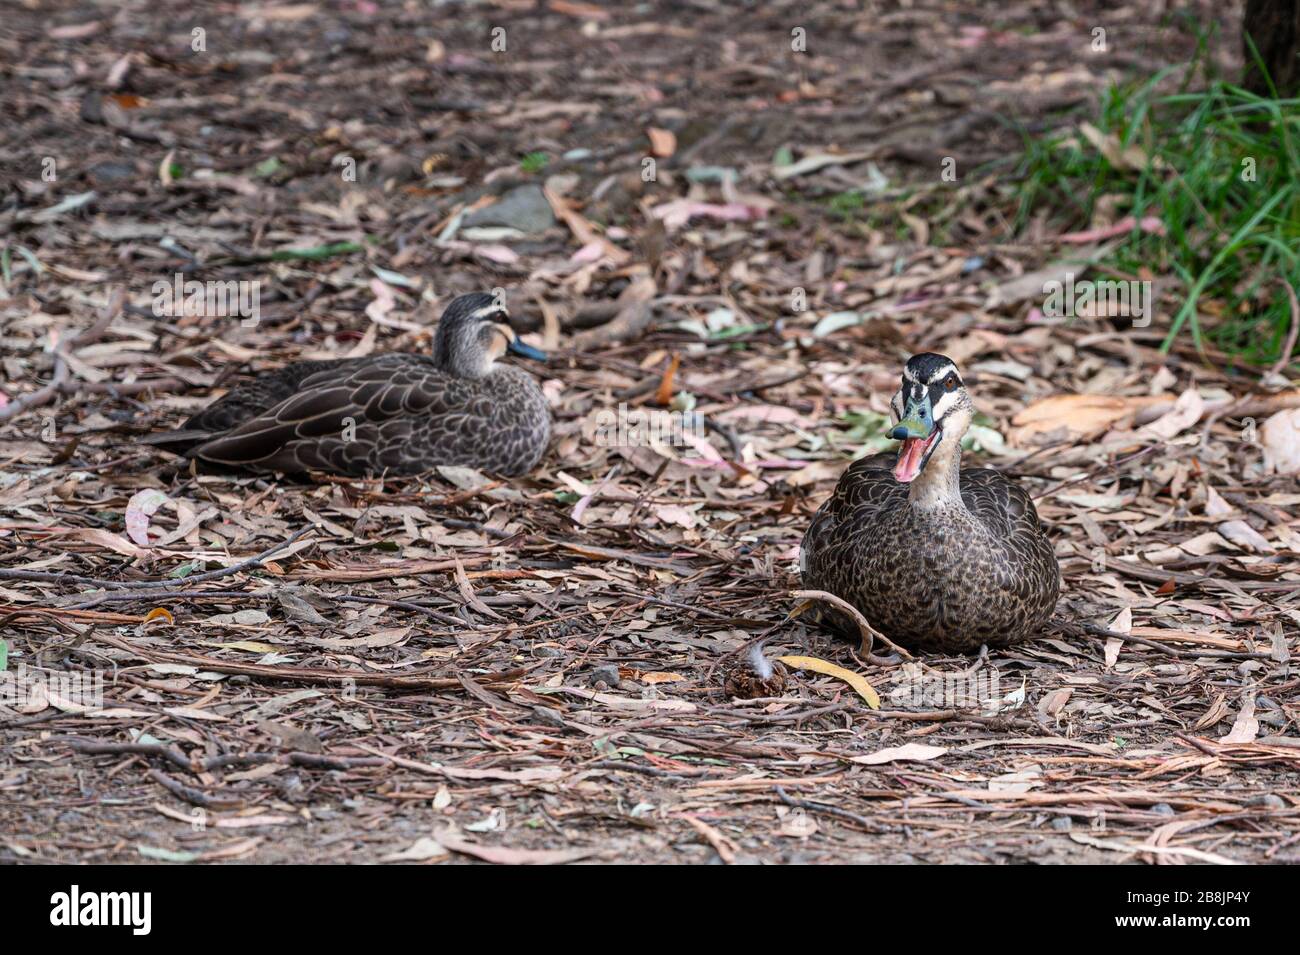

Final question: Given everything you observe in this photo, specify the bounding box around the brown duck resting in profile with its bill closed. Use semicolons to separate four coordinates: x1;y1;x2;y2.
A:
147;292;551;476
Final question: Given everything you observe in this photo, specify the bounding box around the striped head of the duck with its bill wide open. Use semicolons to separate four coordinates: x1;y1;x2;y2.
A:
889;352;975;483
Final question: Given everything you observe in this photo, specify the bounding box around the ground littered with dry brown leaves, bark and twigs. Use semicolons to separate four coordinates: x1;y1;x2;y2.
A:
0;0;1300;863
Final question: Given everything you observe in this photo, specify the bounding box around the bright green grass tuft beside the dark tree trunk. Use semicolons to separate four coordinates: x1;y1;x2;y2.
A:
1017;60;1300;364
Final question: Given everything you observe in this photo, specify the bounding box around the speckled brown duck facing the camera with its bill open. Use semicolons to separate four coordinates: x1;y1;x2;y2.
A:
800;352;1061;654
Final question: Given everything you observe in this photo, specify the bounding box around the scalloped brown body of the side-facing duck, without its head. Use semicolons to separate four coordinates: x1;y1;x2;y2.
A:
191;355;549;474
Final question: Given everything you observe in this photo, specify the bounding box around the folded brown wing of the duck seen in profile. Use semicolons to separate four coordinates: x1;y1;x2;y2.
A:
191;356;449;470
